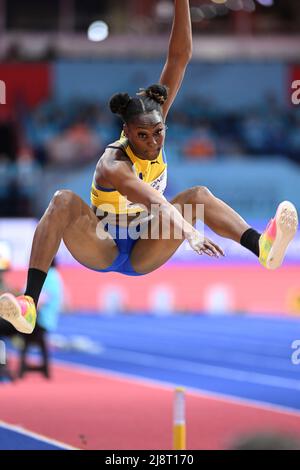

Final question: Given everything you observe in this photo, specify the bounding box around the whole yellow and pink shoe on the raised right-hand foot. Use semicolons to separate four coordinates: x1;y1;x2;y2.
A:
259;201;298;269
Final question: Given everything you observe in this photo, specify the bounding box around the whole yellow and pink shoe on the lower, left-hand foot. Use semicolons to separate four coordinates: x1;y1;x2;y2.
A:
0;294;36;334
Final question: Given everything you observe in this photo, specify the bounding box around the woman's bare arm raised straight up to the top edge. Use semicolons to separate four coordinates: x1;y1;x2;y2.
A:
159;0;193;118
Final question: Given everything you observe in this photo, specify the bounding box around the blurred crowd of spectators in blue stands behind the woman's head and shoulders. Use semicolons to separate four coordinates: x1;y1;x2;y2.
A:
0;96;300;217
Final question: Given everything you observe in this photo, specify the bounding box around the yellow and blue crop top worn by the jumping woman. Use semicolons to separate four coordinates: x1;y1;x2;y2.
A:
91;134;167;214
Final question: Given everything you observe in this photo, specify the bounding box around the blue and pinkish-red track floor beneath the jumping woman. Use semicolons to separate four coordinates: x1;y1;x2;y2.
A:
0;313;300;450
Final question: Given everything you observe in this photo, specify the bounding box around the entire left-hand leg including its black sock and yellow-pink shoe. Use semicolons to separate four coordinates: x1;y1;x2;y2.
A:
0;191;118;333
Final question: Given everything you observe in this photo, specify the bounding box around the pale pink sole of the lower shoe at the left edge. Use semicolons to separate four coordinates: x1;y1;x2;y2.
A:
0;294;34;334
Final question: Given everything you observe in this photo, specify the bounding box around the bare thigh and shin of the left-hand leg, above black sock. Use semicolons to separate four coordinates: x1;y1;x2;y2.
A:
29;190;118;272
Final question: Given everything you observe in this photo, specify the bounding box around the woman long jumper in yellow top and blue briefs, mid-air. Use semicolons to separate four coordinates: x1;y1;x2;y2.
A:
0;0;298;333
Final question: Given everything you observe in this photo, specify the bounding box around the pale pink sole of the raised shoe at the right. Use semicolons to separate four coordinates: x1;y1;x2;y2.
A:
266;201;298;269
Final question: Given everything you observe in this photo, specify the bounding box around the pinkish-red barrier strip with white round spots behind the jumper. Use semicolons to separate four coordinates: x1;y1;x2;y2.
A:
6;265;300;314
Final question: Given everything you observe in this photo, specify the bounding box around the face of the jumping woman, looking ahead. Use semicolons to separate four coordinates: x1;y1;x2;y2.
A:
124;111;166;160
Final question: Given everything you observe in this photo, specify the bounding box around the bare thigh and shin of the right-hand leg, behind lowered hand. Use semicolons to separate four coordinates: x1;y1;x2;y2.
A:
130;186;250;273
